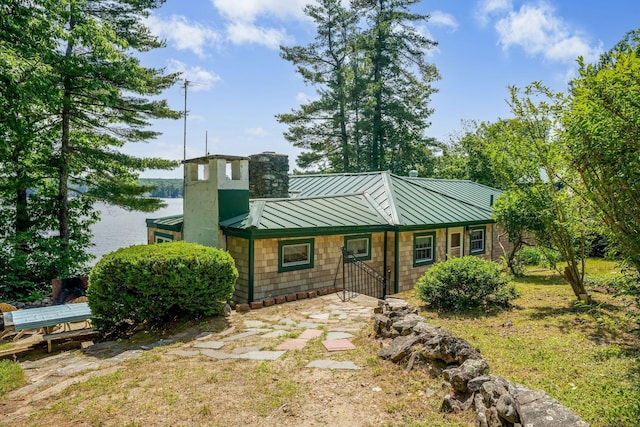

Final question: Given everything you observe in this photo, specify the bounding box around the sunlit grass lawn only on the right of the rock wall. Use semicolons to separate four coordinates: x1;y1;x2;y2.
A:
407;259;640;427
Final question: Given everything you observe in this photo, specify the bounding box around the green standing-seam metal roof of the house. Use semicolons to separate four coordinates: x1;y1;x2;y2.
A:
147;172;501;233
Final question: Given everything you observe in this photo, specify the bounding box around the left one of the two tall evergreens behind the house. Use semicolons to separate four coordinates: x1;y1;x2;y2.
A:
276;0;358;172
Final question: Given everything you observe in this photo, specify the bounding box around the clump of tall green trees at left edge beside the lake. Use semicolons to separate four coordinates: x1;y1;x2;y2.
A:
0;0;180;295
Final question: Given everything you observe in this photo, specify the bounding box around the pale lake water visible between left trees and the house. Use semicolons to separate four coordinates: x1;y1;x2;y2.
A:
89;199;182;262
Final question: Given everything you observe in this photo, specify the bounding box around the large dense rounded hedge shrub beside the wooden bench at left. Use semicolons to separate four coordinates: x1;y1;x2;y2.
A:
87;242;238;335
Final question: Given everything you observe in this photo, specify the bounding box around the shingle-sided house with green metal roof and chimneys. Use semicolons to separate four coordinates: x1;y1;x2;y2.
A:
147;153;506;303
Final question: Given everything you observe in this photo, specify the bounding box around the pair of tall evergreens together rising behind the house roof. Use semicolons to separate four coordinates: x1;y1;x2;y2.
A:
277;0;438;173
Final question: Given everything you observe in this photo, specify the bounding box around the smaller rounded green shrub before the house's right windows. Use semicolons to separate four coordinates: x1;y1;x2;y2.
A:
416;256;518;311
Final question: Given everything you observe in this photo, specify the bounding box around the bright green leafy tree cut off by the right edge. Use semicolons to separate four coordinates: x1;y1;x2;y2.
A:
563;30;640;278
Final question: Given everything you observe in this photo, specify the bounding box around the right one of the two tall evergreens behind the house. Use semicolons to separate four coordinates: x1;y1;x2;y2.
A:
353;0;439;173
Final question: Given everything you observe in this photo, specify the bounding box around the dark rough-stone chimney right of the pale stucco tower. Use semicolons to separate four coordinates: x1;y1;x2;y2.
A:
249;151;289;199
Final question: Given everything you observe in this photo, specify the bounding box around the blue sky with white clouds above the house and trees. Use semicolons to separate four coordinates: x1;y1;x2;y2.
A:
130;0;640;177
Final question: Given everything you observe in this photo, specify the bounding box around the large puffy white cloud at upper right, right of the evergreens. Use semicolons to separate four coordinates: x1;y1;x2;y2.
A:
495;2;601;63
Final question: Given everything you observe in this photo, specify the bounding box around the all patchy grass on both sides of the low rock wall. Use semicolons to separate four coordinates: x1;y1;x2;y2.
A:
7;261;640;427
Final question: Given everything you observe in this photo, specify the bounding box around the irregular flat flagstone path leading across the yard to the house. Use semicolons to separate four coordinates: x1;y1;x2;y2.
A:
6;294;378;419
